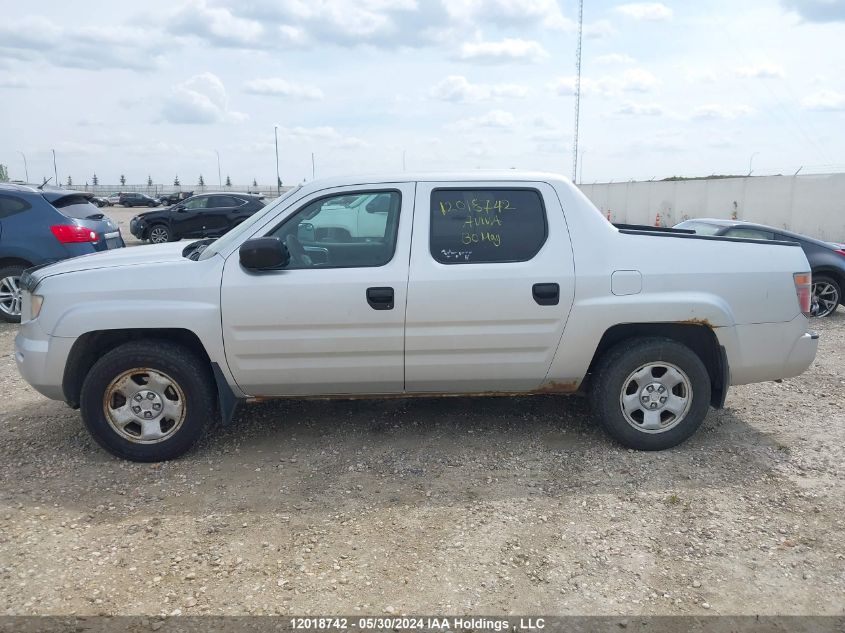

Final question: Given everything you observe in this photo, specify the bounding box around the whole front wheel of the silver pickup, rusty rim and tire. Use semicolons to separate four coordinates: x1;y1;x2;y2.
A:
80;340;216;462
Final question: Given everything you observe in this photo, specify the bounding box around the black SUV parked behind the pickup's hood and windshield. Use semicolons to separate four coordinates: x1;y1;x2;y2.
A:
129;193;264;244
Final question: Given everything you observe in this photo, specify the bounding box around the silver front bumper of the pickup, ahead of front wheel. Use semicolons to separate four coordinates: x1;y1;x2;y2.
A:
15;321;75;400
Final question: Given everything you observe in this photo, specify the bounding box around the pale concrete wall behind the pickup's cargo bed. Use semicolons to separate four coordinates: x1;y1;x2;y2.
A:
581;174;845;242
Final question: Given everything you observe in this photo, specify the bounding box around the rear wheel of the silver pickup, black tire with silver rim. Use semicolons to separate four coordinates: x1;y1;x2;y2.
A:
591;337;711;451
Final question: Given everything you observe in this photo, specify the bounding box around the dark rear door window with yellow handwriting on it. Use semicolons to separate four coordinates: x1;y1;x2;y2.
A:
429;189;548;264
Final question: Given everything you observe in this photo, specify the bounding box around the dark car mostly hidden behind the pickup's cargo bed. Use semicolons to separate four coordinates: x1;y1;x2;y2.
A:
674;218;845;317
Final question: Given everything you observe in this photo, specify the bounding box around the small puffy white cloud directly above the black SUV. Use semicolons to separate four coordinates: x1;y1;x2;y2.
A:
161;72;248;124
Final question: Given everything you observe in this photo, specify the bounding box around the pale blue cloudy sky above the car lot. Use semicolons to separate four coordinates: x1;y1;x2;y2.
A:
0;0;845;184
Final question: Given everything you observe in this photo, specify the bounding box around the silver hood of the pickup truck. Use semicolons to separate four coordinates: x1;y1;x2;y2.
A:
21;242;190;290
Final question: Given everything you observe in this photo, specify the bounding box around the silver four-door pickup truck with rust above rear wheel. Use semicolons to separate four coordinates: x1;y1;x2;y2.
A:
16;171;817;461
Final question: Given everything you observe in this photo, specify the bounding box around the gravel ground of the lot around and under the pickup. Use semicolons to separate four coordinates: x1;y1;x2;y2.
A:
0;266;845;615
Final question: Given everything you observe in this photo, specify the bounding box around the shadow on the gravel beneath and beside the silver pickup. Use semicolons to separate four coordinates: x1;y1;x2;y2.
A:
0;396;789;515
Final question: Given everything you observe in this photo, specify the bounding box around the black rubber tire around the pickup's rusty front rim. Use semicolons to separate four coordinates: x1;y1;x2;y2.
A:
79;340;217;462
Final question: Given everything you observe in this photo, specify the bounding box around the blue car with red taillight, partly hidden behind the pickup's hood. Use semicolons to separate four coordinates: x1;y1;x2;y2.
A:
0;184;124;323
